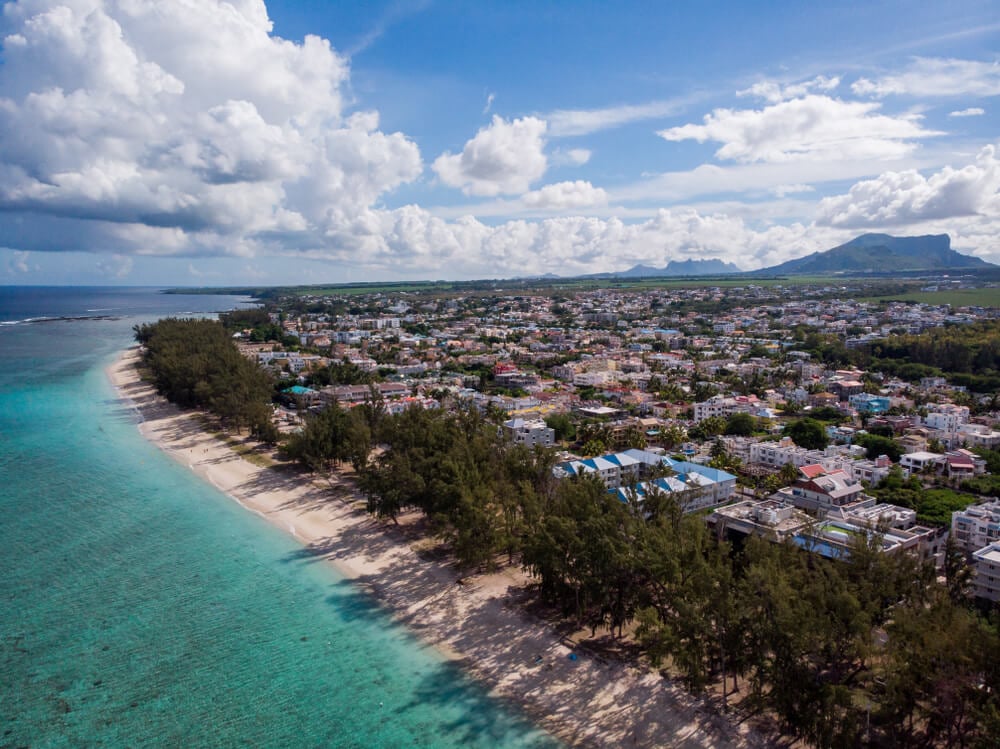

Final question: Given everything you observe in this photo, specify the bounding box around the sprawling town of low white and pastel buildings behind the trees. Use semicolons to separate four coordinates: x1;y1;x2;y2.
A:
235;282;1000;602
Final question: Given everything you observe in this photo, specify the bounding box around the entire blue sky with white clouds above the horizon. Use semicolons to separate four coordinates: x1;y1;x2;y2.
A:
0;0;1000;286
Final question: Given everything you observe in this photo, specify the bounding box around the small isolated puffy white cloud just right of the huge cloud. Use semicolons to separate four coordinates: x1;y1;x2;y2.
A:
433;115;548;195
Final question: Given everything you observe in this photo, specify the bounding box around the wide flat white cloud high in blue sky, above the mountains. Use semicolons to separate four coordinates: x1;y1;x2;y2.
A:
658;94;941;163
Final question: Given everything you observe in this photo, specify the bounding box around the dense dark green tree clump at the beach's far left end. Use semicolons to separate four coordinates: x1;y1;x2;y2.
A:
134;318;277;442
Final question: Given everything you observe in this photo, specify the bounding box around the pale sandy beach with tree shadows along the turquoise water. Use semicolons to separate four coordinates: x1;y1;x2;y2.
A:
107;346;751;749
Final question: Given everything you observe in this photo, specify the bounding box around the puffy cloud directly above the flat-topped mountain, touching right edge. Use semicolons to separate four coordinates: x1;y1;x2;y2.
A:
816;146;1000;229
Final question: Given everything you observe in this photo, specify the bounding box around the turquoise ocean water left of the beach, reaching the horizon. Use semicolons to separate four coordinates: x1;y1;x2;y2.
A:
0;287;559;747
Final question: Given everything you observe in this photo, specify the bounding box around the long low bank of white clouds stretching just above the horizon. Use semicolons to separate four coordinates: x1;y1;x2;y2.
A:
286;200;849;278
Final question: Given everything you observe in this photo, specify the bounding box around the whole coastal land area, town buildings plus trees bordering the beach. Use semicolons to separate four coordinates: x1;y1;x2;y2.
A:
135;280;1000;746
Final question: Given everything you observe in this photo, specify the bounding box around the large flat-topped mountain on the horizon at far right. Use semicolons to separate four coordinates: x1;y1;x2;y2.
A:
757;234;996;276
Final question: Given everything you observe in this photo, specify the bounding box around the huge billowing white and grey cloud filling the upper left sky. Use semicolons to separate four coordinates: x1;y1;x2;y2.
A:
0;0;422;255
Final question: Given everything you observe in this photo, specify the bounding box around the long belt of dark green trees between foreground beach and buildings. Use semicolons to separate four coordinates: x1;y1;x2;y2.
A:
286;406;1000;747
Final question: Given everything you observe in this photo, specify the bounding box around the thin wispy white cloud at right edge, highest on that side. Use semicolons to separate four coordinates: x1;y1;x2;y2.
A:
851;57;1000;97
